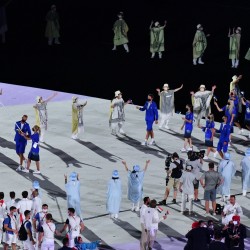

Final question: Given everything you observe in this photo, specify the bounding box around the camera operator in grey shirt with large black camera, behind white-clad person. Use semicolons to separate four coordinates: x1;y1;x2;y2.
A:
186;150;205;202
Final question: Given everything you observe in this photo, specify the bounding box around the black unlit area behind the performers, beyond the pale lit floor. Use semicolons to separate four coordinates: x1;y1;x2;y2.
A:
0;0;250;119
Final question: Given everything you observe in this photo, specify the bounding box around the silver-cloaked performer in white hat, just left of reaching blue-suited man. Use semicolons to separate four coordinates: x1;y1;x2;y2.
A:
109;90;131;135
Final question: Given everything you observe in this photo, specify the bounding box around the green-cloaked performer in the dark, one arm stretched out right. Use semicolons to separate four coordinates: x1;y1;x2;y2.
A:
193;24;210;65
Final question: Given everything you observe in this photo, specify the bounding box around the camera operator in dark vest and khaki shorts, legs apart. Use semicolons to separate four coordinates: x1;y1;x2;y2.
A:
159;152;183;205
